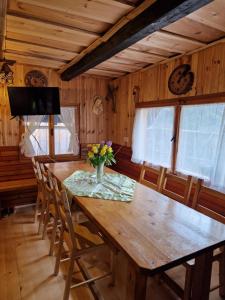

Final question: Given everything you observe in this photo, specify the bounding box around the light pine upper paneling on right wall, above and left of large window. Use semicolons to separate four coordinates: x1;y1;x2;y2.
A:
107;42;225;146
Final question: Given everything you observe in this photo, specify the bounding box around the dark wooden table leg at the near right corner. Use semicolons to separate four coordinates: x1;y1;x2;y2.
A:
191;251;213;300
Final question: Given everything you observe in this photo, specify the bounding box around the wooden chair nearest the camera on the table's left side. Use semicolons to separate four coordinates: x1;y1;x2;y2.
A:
53;179;112;300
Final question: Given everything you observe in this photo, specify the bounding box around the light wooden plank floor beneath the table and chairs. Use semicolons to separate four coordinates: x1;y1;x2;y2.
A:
0;207;221;300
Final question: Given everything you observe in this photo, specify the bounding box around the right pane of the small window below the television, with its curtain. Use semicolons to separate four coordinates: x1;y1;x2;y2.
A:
54;107;79;155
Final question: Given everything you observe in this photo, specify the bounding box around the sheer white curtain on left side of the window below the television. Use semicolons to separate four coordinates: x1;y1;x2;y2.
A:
20;115;45;157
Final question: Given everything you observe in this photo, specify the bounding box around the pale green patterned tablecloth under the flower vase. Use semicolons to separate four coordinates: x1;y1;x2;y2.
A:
63;171;136;201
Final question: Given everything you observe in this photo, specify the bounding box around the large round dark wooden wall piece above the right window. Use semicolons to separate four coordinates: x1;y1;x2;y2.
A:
168;64;194;95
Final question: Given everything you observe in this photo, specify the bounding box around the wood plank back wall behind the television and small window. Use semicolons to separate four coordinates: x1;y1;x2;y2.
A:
0;64;109;209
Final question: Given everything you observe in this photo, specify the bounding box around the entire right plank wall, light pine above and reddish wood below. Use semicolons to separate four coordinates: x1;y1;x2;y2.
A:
107;42;225;220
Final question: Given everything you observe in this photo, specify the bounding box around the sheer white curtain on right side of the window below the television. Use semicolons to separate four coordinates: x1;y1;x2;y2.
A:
59;107;79;155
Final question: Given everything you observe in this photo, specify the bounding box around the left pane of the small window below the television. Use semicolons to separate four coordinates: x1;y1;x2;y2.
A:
25;116;49;155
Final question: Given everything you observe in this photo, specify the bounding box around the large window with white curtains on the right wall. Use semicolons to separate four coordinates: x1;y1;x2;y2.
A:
132;102;225;190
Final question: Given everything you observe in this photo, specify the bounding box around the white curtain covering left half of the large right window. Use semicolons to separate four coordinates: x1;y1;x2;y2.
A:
131;107;174;167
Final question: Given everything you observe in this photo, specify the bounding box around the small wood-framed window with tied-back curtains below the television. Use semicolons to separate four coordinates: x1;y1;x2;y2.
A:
21;107;79;156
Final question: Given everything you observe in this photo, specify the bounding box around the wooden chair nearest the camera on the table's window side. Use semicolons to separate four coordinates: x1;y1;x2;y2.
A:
162;178;225;300
